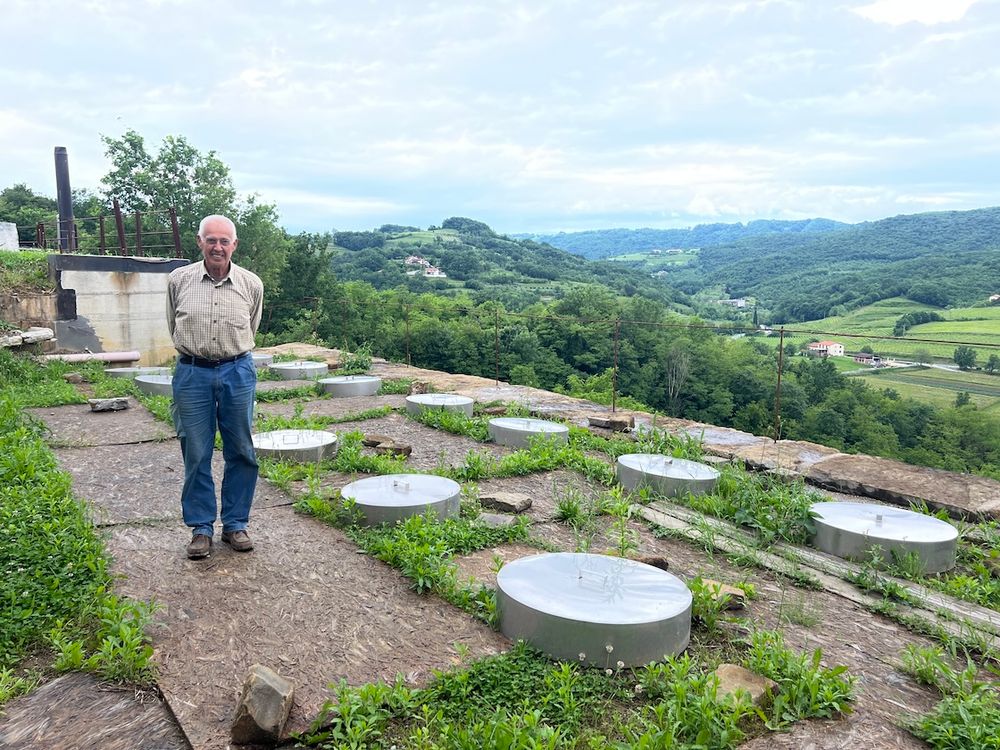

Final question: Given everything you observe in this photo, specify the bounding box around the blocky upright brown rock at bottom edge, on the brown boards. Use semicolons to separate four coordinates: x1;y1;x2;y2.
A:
230;664;295;745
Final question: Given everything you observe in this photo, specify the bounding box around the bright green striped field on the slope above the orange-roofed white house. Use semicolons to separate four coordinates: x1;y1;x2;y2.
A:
772;297;1000;364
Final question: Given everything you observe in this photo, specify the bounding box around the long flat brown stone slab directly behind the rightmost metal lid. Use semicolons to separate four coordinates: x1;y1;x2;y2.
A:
805;454;1000;519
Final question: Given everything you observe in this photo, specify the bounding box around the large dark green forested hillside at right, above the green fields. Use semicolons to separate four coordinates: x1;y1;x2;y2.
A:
669;208;1000;322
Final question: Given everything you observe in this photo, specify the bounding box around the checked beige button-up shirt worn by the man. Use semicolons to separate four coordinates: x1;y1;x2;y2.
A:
167;261;264;359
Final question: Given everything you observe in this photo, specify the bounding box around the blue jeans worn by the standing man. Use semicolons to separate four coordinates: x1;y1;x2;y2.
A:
172;355;257;537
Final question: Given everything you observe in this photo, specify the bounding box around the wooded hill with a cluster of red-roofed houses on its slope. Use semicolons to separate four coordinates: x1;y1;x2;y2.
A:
330;217;688;311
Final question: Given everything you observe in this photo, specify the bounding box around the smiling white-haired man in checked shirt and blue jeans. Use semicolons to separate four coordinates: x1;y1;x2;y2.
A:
167;216;264;560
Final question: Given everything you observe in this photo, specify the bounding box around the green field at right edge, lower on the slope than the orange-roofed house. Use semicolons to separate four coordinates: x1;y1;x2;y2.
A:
857;367;1000;413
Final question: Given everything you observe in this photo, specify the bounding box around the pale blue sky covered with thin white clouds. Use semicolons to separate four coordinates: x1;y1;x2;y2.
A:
0;0;1000;233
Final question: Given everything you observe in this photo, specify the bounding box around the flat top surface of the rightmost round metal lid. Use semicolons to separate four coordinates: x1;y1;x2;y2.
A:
811;502;958;542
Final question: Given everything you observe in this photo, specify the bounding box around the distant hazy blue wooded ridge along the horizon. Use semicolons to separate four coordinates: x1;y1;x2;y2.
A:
515;219;850;259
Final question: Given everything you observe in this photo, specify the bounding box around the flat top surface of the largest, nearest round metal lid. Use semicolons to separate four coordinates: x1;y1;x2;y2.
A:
497;552;691;625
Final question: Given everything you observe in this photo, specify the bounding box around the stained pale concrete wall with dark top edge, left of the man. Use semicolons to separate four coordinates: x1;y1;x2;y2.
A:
49;254;187;365
